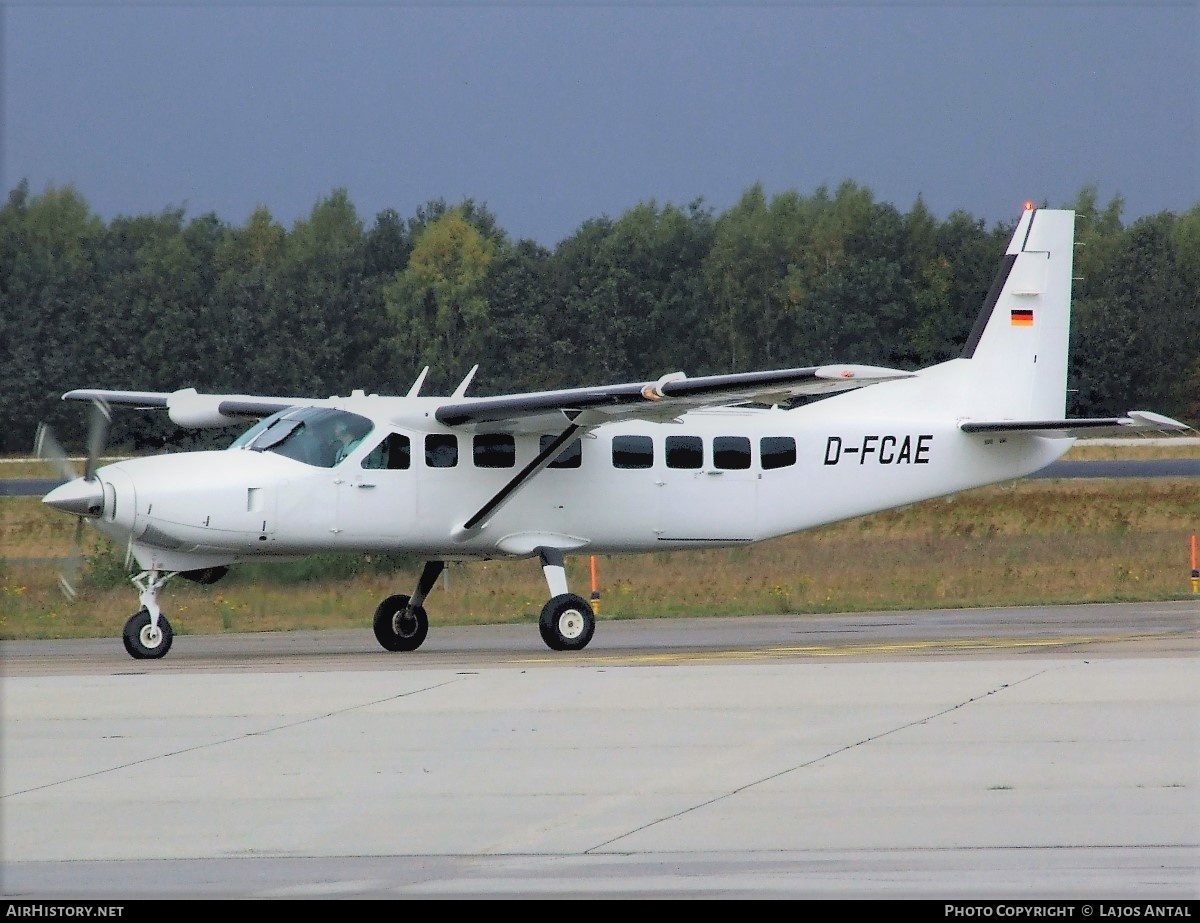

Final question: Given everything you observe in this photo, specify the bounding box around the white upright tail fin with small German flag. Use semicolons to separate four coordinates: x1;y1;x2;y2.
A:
961;209;1075;420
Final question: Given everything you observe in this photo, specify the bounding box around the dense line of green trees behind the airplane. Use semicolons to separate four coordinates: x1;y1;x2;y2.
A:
0;181;1200;454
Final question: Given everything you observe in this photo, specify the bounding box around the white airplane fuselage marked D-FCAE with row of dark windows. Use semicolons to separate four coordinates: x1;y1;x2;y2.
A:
88;401;1072;570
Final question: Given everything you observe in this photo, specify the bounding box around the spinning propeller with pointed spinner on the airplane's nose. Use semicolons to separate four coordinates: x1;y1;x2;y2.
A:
34;401;113;600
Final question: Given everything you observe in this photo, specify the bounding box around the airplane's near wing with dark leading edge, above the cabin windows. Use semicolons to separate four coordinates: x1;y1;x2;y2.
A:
434;365;913;431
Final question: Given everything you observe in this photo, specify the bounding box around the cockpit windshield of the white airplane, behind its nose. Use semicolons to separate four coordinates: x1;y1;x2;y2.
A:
229;407;374;468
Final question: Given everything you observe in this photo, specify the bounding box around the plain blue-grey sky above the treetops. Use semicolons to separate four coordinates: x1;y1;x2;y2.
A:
0;0;1200;246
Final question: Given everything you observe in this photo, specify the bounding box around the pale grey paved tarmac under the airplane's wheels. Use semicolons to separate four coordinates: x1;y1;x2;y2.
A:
0;599;1200;901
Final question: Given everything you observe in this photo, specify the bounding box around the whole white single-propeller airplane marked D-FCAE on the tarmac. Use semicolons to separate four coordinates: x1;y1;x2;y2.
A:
40;208;1187;658
